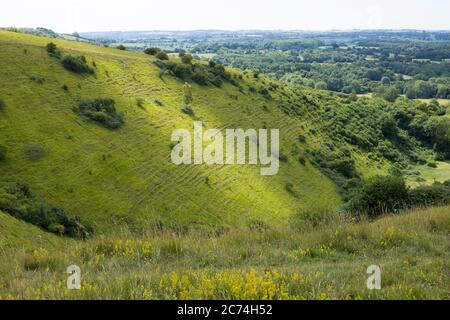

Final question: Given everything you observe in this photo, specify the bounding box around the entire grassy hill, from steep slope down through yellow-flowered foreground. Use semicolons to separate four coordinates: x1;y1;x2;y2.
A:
0;31;449;299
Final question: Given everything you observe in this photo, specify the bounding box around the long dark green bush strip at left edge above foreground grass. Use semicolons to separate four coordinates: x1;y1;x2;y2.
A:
0;183;93;238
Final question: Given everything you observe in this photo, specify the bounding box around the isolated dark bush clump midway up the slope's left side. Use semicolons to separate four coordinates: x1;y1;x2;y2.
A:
76;99;124;129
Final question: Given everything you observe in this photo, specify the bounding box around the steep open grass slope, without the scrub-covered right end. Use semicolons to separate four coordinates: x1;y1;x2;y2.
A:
0;32;340;231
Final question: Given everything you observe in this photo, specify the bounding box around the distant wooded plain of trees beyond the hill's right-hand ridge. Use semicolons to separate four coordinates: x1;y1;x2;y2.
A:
209;40;450;99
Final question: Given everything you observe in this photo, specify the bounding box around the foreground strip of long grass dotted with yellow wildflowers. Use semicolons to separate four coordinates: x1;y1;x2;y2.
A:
0;207;450;300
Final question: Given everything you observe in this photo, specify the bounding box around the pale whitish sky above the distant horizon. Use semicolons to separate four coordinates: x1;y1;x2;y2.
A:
0;0;450;33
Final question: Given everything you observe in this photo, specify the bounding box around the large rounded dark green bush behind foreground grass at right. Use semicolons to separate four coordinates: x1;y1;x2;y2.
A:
349;176;408;218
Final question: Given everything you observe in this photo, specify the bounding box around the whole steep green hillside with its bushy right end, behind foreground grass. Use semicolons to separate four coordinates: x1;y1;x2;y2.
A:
0;31;445;233
